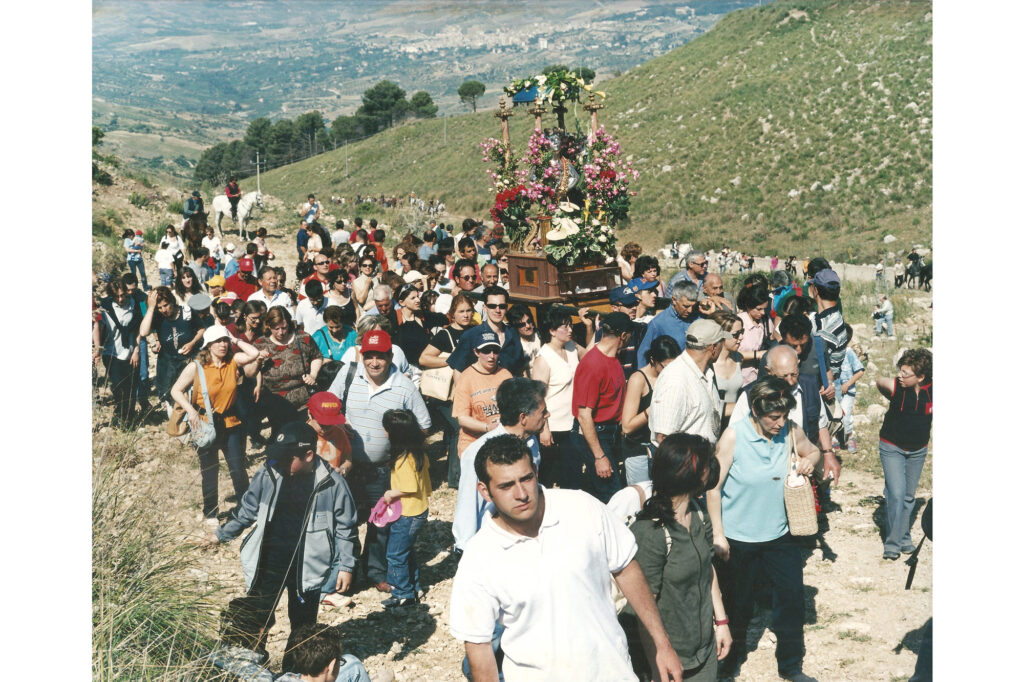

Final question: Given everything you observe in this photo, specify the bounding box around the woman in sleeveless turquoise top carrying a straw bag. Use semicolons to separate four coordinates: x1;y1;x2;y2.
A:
708;377;821;680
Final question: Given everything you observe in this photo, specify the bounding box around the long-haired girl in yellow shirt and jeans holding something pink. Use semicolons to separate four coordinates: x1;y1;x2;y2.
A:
382;410;431;608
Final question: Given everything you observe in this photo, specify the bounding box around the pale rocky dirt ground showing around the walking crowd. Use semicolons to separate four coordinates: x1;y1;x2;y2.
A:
94;183;933;680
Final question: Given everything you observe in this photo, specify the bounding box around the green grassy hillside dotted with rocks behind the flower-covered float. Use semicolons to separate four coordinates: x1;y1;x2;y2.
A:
264;2;932;261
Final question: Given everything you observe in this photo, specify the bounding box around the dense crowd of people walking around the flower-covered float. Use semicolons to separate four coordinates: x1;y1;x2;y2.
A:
93;195;932;680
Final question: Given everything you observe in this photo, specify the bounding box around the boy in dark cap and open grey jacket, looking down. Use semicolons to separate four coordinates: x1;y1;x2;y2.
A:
209;422;357;639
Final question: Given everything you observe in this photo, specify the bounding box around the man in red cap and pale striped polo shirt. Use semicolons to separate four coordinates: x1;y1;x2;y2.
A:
329;330;430;592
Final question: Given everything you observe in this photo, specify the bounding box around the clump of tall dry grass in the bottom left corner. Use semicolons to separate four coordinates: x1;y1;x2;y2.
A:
92;433;226;680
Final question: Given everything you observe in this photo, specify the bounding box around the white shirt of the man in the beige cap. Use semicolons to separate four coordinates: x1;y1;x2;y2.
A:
649;350;724;443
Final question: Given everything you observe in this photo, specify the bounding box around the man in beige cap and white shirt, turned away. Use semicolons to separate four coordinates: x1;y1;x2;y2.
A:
648;319;726;442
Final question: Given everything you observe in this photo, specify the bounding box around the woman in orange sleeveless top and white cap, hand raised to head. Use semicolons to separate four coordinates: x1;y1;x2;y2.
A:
171;325;266;526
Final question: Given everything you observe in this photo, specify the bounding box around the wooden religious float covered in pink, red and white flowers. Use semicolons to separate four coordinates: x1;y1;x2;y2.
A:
481;71;639;312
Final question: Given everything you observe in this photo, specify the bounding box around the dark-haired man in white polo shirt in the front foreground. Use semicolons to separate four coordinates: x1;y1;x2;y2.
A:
450;434;683;682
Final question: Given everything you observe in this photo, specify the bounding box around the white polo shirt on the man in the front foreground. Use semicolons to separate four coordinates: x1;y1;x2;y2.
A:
449;489;637;682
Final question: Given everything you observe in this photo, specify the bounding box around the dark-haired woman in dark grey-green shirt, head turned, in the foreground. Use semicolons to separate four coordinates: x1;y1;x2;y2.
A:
631;433;732;682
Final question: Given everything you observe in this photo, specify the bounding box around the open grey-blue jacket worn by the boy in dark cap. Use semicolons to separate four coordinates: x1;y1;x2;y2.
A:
217;457;357;592
